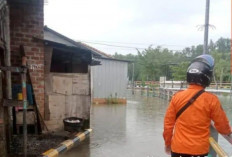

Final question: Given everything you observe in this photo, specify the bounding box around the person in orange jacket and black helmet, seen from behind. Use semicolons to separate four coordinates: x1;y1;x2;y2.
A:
163;55;231;157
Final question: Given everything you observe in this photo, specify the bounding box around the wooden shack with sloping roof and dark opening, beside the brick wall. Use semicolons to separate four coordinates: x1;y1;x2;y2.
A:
43;27;98;131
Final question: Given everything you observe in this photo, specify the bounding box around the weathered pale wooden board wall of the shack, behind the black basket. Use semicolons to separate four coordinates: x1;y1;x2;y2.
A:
45;47;91;131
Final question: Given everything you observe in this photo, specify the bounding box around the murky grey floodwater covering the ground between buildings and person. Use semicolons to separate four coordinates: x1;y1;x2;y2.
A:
62;91;232;157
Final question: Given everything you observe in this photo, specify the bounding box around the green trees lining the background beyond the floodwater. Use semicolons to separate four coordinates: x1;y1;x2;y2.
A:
113;38;231;83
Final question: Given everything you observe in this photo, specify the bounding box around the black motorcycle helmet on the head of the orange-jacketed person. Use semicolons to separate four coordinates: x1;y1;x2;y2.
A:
187;55;214;87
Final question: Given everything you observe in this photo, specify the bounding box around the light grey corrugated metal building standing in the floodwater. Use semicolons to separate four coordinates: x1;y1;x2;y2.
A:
91;57;129;104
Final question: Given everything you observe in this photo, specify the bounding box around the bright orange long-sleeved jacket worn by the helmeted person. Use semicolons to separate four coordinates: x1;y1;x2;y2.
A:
163;85;231;155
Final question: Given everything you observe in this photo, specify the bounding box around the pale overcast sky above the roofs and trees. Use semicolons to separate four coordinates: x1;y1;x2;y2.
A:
44;0;231;54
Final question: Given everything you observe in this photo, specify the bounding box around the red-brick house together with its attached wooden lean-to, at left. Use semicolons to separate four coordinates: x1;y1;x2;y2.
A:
0;0;94;157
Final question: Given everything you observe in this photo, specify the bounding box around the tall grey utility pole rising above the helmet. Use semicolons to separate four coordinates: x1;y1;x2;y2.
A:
203;0;210;54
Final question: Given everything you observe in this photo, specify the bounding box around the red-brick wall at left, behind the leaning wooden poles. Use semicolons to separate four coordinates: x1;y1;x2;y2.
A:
10;0;44;115
